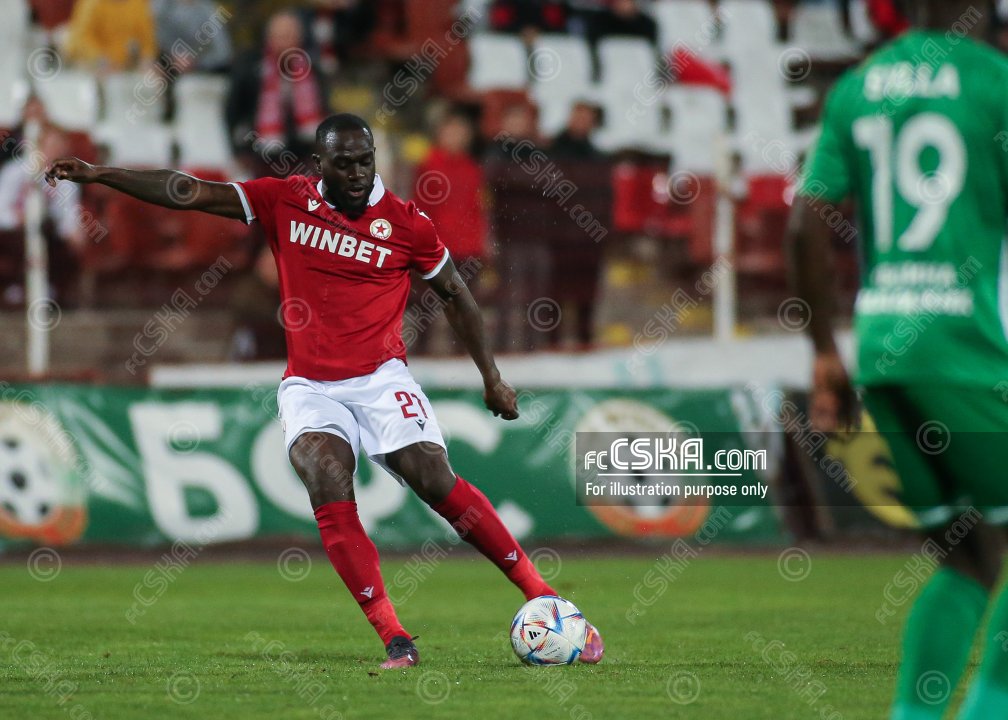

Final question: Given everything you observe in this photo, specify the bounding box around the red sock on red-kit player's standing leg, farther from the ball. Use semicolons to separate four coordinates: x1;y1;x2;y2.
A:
316;502;409;644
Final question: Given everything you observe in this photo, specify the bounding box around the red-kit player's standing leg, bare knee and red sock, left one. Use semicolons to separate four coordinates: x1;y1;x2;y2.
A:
290;432;415;665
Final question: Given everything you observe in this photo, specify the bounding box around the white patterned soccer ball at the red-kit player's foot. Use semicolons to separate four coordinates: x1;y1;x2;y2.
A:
511;595;588;665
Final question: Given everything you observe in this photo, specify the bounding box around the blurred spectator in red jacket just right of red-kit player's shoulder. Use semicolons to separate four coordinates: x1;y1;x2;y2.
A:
407;112;487;353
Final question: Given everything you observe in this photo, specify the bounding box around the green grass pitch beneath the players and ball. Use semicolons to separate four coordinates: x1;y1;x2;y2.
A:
0;552;962;720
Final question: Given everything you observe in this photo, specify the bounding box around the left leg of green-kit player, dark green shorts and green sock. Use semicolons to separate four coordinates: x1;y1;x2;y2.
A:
865;386;1000;720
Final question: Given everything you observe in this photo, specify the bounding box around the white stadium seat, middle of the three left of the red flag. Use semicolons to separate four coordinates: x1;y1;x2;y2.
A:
531;34;593;136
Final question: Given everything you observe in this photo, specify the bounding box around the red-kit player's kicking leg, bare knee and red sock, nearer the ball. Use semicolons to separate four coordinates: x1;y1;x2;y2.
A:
385;442;556;599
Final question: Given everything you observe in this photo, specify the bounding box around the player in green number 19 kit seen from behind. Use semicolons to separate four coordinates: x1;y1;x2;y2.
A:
788;0;1008;720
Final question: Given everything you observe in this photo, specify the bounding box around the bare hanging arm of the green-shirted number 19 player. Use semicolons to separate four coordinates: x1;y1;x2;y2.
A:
787;195;857;433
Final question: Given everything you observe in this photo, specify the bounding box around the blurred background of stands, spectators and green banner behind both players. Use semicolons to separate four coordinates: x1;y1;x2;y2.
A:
0;0;983;546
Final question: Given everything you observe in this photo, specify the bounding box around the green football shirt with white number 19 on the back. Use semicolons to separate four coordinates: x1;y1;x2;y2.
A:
798;31;1008;388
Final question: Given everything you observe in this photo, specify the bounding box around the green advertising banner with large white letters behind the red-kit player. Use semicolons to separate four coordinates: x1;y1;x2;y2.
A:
0;383;783;551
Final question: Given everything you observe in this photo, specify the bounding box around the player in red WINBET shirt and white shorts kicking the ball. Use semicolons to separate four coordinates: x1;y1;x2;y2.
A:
45;113;603;670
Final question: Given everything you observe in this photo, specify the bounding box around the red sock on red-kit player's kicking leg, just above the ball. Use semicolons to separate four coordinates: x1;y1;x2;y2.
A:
431;475;556;600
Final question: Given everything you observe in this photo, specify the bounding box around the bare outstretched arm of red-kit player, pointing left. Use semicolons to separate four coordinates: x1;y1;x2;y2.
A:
45;157;245;220
